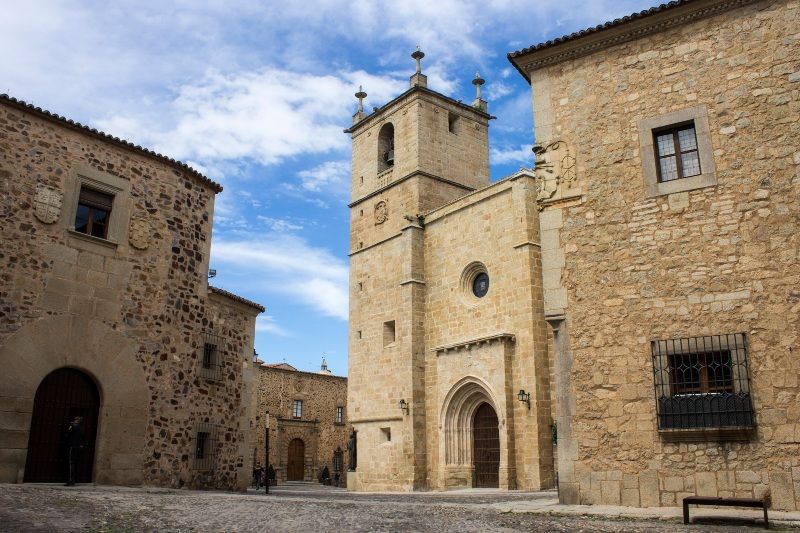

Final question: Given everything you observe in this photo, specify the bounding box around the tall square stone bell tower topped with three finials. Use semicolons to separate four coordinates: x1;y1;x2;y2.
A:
345;47;494;490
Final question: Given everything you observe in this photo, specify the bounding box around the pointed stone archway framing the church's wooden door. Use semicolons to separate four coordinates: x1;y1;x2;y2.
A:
440;377;509;488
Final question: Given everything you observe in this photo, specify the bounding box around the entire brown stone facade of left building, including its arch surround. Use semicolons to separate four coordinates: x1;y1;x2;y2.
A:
0;96;263;490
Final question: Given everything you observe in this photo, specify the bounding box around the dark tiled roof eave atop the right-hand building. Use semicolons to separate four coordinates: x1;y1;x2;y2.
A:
508;0;762;83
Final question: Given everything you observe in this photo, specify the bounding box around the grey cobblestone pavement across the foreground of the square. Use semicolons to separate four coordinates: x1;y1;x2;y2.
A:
0;485;796;533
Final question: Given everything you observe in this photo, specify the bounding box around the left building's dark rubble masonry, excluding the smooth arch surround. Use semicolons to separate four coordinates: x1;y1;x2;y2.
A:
0;100;257;489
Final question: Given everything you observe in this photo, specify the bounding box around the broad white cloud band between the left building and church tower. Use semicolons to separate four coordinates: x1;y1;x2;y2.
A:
211;234;348;320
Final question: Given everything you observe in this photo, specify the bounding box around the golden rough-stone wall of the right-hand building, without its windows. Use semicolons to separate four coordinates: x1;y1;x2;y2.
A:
532;1;800;510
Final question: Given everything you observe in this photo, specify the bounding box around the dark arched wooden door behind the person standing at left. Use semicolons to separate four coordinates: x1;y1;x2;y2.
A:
24;368;100;483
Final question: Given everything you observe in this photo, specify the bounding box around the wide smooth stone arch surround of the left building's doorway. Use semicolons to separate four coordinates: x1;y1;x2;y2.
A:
0;315;150;485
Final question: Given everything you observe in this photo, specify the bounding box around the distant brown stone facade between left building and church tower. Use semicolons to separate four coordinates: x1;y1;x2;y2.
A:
251;364;352;486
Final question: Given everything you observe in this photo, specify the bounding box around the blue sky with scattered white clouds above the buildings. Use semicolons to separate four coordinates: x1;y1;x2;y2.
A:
0;0;655;375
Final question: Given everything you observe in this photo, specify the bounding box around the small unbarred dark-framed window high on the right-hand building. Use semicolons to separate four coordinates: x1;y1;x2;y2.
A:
653;121;702;183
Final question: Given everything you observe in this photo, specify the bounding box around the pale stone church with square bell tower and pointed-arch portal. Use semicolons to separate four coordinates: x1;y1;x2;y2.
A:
347;50;553;490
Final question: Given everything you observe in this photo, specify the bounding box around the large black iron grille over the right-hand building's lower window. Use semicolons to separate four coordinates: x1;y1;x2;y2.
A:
651;333;755;430
